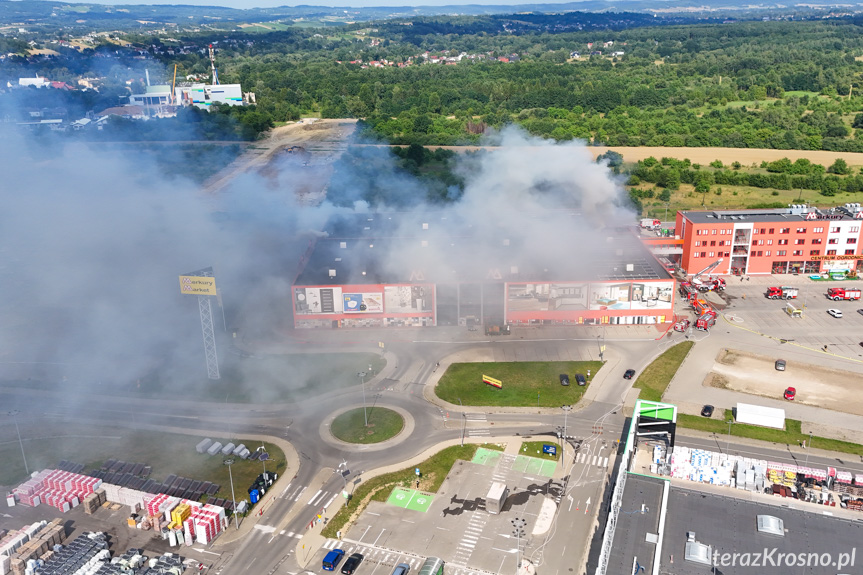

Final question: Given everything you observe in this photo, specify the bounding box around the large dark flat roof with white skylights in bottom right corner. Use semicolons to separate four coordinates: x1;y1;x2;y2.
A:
660;483;863;575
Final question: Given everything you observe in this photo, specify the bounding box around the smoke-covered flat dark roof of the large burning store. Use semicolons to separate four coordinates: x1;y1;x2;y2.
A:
294;213;671;285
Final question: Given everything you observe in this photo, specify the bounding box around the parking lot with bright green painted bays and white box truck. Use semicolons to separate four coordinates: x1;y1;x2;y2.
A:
312;452;562;575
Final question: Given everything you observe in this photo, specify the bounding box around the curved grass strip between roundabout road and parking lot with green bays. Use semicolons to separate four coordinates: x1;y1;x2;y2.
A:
321;444;486;537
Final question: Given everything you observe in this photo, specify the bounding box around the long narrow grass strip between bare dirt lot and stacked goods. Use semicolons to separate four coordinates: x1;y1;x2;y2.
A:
677;410;863;456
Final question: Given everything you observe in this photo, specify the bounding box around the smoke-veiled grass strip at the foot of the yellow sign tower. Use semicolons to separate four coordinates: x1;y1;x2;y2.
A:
0;352;386;403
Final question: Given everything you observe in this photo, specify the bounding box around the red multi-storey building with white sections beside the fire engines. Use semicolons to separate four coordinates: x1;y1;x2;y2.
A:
675;204;863;275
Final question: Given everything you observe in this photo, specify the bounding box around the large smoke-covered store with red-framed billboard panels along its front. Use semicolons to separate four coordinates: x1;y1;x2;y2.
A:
292;213;675;328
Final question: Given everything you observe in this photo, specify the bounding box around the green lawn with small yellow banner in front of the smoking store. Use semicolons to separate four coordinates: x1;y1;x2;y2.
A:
435;361;602;407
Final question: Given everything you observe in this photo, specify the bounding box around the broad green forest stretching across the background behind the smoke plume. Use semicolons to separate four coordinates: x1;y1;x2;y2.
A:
130;16;863;151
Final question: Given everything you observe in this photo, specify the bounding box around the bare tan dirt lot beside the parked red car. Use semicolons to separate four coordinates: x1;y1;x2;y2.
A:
703;350;863;415
